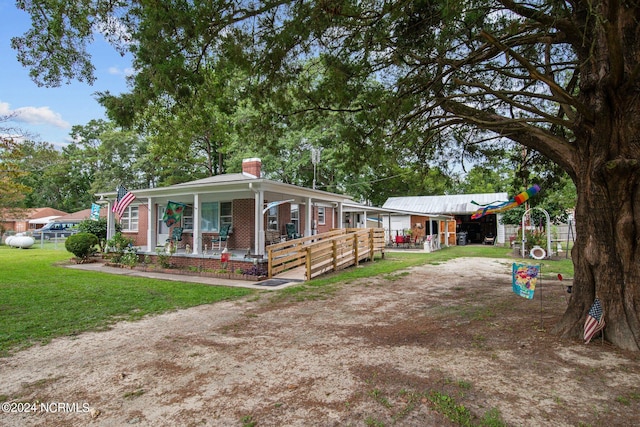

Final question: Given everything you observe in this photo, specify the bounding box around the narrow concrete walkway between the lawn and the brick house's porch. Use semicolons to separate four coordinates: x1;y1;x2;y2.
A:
66;262;303;291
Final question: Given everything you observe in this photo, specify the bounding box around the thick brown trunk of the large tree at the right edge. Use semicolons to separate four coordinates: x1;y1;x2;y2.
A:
557;2;640;351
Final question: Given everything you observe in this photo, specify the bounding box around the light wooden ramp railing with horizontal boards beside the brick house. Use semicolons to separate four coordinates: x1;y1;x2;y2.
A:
266;228;385;280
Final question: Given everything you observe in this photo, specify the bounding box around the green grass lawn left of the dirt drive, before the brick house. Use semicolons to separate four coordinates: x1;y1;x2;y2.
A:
0;246;254;356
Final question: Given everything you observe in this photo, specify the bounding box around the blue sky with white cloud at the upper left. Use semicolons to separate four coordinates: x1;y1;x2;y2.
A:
0;0;132;147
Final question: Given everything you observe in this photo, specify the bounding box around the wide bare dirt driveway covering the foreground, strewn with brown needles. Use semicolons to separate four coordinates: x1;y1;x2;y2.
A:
0;258;640;426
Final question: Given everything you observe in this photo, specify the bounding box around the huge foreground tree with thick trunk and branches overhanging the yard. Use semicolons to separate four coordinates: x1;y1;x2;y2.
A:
13;0;640;350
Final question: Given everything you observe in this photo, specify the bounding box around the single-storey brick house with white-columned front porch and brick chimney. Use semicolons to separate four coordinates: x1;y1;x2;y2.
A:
96;158;351;255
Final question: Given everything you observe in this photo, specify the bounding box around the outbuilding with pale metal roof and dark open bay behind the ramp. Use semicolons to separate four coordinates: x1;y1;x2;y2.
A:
383;193;509;244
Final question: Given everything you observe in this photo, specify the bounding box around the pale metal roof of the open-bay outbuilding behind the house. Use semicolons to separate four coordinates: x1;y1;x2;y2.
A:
383;193;509;215
